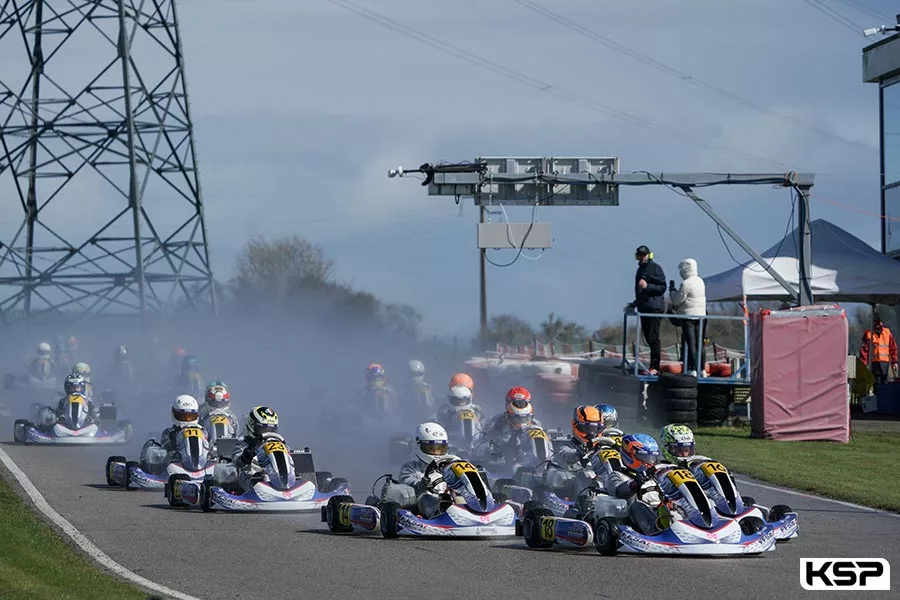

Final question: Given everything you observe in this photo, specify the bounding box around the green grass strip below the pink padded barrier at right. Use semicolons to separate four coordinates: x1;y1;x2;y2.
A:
696;428;900;512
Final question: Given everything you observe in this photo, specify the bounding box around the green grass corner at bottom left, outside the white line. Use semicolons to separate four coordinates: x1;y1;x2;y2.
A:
0;477;148;600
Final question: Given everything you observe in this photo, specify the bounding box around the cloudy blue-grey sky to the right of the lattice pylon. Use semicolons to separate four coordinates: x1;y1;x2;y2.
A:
0;0;894;335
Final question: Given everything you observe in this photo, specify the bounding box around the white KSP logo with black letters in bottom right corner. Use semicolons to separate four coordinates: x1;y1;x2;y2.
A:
800;558;891;591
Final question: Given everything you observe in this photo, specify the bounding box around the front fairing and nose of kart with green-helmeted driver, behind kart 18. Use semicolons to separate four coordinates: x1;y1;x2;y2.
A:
690;461;800;542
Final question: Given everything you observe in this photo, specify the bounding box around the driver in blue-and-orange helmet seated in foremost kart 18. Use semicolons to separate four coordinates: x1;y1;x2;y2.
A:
592;433;661;535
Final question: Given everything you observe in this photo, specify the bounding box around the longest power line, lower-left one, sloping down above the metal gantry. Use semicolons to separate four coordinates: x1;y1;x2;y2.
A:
327;0;874;189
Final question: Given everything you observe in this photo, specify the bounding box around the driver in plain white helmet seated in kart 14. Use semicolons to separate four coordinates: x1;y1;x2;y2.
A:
400;423;460;519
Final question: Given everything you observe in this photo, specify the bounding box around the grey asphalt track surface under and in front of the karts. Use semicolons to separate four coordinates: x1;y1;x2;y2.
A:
3;426;900;600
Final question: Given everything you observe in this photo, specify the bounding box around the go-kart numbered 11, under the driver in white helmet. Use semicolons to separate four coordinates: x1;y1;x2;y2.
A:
106;427;217;490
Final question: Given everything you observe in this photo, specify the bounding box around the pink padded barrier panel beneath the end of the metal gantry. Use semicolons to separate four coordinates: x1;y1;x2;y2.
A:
750;305;850;443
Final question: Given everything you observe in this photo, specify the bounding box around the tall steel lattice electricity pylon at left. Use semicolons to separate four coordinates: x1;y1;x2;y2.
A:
0;0;216;323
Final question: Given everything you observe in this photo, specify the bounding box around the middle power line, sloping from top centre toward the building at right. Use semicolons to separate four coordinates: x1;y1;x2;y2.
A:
512;0;878;157
